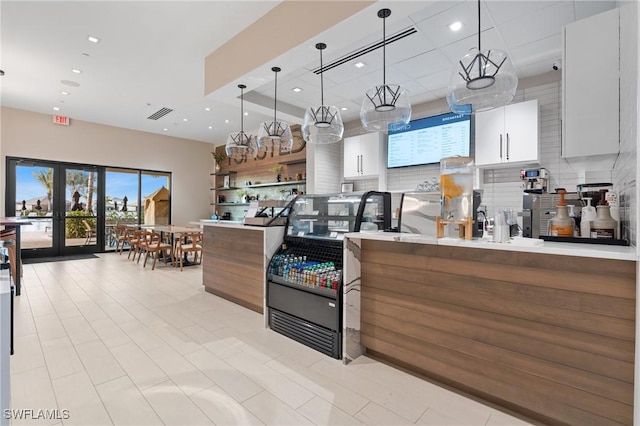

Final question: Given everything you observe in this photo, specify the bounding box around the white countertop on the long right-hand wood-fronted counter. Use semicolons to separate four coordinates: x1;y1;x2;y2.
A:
345;232;638;261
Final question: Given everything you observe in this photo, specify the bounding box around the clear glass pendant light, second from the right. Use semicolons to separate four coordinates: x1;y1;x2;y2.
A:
360;9;411;132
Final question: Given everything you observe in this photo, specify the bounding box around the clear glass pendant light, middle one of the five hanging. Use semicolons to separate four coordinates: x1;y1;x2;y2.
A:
302;43;344;144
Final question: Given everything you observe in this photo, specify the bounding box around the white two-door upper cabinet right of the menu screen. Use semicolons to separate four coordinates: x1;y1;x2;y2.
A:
475;99;540;166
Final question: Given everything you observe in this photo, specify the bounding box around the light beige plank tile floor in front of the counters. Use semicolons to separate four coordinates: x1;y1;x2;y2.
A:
11;253;528;426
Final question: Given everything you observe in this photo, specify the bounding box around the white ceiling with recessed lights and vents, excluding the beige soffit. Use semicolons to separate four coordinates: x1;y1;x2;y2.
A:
0;0;617;145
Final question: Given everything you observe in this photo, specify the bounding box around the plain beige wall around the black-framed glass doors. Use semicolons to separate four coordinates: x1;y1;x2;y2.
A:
0;108;214;225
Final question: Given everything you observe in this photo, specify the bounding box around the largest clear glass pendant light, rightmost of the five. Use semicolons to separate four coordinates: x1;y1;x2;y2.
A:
447;0;518;115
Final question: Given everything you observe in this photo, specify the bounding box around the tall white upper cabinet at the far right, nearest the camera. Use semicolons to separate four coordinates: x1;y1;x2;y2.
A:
562;8;620;170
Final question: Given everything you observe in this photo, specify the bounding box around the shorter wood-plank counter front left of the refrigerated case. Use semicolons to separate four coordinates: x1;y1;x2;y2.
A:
202;226;264;313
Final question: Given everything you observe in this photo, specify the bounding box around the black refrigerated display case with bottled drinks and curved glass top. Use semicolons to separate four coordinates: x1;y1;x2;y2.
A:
267;191;391;359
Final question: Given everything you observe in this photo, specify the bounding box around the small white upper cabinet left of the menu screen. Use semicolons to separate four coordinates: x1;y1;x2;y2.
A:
344;132;384;179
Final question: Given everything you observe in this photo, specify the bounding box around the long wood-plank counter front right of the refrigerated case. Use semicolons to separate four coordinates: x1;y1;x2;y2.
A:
361;240;636;425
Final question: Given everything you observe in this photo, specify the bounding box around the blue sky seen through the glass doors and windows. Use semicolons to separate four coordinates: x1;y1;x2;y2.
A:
16;165;168;204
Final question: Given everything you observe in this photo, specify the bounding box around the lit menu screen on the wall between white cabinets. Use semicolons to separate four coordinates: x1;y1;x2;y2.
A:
387;112;473;169
